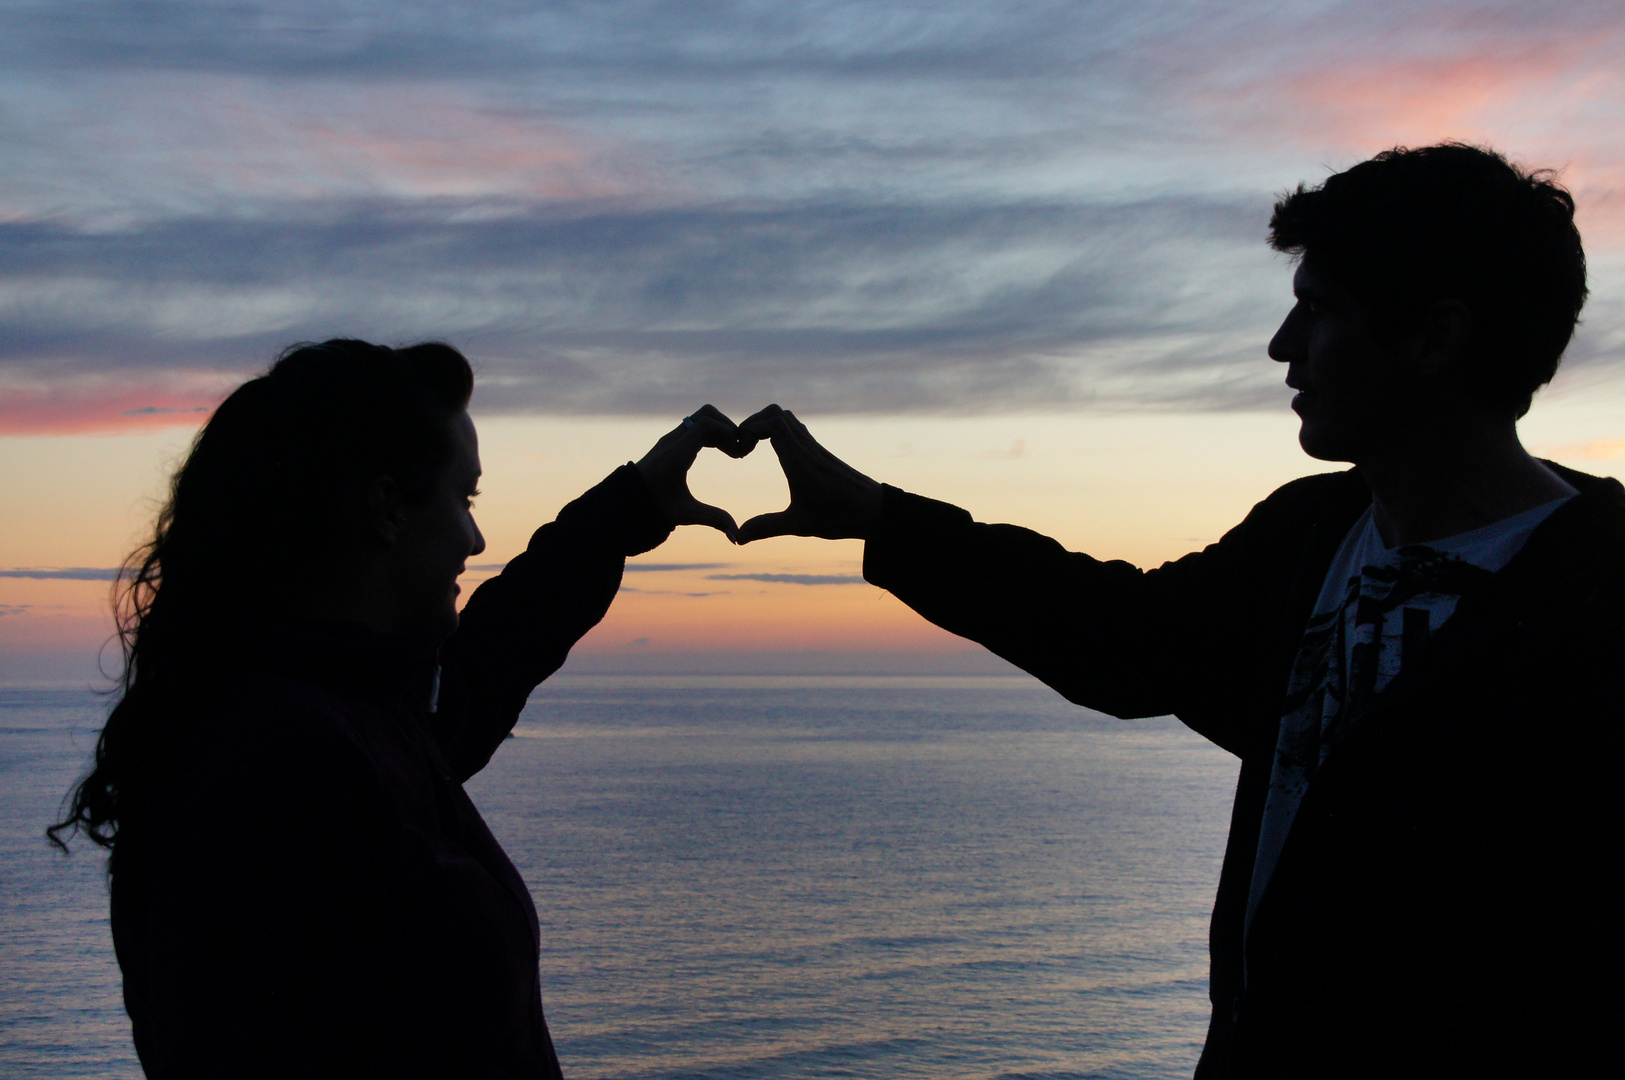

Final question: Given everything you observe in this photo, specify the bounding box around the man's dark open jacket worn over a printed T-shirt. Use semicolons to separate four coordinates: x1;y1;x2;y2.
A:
863;469;1625;1080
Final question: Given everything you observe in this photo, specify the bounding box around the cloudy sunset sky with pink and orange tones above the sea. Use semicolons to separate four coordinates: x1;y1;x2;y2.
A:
0;0;1625;682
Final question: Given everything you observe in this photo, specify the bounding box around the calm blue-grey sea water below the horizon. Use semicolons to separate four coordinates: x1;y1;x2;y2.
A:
0;676;1235;1080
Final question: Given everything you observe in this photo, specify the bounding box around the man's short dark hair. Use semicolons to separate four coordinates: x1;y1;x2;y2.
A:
1269;143;1586;456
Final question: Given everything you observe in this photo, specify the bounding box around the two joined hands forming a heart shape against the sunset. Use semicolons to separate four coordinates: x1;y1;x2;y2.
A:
637;404;882;544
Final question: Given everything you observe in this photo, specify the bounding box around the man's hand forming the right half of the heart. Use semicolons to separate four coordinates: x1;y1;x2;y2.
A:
738;404;881;544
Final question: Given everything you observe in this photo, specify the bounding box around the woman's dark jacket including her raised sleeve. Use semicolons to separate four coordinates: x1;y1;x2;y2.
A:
112;466;671;1080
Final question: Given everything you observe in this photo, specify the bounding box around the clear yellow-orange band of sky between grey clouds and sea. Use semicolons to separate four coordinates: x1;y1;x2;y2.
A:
0;396;1625;682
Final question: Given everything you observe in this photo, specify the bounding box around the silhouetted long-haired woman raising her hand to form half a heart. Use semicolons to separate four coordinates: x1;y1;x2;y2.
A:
52;341;739;1078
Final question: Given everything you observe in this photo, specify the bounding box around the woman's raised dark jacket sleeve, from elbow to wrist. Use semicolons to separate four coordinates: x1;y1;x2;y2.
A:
432;464;673;780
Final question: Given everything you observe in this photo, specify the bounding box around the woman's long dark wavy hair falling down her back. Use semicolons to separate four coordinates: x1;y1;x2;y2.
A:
46;339;473;851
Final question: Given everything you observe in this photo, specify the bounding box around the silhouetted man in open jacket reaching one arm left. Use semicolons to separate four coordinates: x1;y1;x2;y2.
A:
741;145;1625;1080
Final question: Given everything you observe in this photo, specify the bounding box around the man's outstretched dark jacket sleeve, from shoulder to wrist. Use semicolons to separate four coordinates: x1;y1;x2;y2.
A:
863;476;1357;752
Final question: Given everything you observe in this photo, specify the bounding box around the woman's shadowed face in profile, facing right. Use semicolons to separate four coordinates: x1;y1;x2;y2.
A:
395;411;486;633
